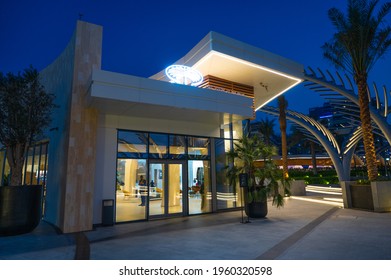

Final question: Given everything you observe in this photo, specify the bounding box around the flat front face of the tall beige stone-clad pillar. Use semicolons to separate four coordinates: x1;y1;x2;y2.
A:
63;21;102;232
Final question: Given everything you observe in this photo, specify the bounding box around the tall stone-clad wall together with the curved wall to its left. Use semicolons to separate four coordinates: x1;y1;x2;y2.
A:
42;21;102;233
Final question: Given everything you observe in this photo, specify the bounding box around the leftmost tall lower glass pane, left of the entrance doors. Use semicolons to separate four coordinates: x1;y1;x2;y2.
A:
115;159;147;222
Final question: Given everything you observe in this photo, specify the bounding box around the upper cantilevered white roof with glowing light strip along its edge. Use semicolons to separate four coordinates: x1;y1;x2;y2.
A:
150;32;304;110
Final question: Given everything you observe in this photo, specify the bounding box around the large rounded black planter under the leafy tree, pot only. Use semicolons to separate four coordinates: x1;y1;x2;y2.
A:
0;185;43;236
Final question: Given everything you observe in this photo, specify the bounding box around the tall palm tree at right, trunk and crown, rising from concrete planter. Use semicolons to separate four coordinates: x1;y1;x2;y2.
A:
322;0;391;181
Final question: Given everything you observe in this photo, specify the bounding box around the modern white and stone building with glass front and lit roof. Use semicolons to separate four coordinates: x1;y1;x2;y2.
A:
0;21;303;233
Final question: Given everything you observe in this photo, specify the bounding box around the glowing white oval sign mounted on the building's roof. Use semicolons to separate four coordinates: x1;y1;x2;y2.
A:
165;65;204;86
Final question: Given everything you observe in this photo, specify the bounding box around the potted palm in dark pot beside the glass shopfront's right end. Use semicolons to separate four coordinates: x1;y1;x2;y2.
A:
226;136;290;218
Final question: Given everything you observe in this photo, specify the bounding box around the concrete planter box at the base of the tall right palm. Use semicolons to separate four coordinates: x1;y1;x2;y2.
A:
341;181;391;212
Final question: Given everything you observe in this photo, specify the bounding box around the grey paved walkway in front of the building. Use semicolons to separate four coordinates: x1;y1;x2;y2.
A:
0;197;391;260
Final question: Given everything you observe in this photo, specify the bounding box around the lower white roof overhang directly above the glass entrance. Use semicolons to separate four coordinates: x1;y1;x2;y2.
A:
86;69;253;126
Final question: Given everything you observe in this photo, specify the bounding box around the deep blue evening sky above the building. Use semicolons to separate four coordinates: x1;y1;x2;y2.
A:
0;0;391;116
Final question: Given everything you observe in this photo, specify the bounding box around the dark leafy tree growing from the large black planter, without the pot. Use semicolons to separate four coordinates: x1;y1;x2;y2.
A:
0;67;55;185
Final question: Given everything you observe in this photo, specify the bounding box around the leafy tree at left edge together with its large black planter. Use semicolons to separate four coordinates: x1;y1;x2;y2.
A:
0;67;55;235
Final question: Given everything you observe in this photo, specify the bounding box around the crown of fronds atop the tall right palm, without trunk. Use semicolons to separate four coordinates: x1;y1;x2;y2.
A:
322;0;391;75
